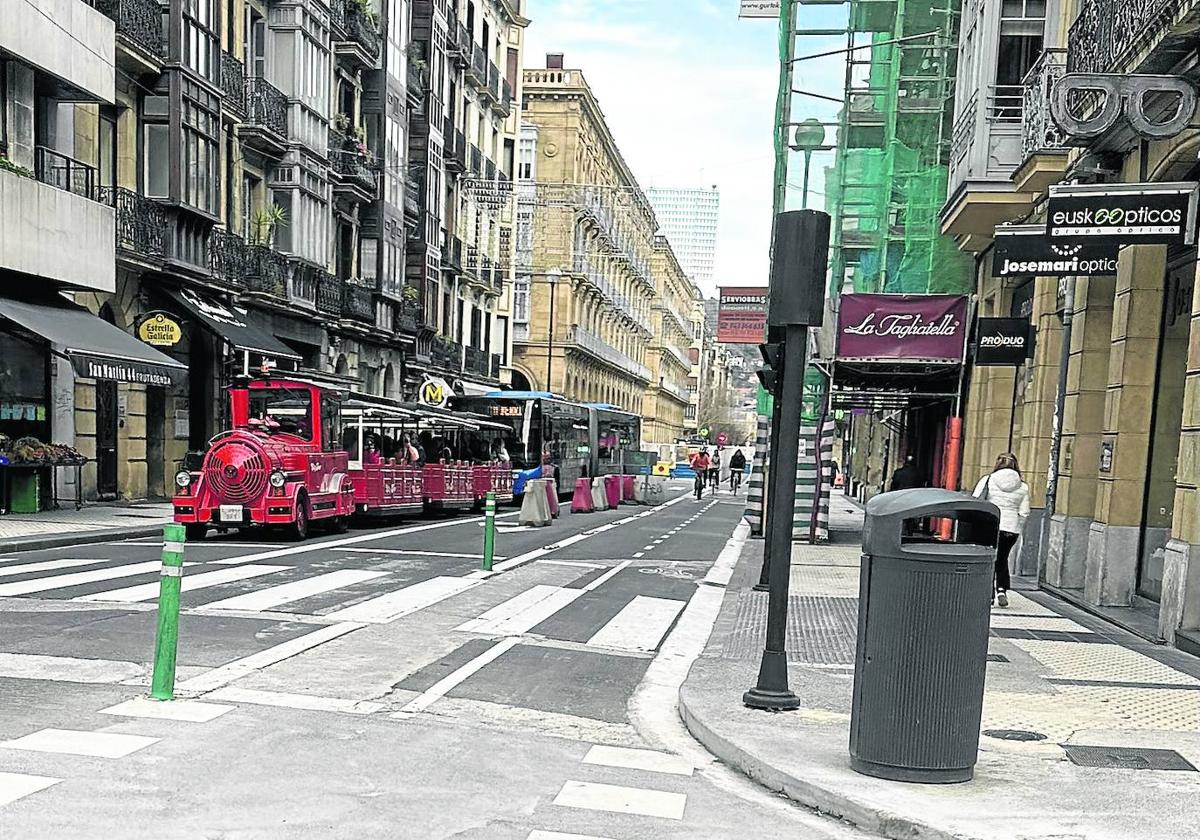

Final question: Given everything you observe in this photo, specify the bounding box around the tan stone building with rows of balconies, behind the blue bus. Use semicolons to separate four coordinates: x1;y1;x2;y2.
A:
512;55;656;412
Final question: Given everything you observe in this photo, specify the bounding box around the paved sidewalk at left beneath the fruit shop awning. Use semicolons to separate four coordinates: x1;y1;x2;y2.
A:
0;502;173;553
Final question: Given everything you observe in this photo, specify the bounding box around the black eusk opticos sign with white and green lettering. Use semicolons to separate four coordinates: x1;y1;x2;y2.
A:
1046;181;1198;245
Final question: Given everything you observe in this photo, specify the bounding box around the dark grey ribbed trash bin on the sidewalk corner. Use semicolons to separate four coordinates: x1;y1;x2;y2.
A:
850;488;1000;782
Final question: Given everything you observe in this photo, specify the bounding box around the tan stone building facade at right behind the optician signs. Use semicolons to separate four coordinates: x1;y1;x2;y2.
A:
942;0;1200;653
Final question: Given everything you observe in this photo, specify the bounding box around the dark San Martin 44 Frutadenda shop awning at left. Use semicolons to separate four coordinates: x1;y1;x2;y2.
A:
0;298;187;385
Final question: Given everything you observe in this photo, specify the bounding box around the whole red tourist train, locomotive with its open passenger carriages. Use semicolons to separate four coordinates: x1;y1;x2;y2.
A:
174;377;512;541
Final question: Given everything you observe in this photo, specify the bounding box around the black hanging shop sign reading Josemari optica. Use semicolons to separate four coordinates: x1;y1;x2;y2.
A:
991;224;1118;277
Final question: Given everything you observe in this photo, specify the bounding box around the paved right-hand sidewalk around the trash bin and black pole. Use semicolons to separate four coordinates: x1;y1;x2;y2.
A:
679;497;1200;840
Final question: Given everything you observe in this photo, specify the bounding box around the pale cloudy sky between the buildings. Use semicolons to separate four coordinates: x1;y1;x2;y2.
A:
524;0;779;294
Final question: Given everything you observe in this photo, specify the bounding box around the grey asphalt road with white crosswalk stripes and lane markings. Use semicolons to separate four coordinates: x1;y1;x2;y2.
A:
0;482;860;840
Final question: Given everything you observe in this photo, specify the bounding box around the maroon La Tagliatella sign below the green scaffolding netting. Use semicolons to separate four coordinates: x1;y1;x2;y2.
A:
838;294;967;362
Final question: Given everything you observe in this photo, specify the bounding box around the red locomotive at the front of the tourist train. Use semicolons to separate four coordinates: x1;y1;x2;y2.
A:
174;379;354;541
